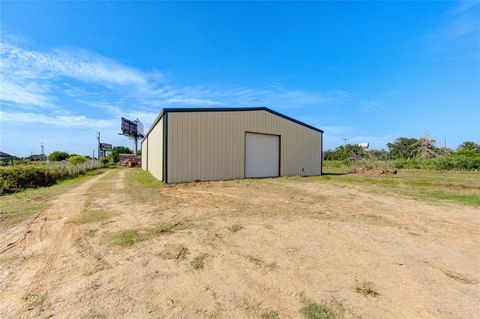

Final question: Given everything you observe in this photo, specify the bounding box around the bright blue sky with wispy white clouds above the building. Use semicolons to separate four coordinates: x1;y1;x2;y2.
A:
0;1;480;156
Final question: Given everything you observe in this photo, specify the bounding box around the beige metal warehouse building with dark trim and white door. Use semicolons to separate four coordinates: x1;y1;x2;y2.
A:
142;107;323;183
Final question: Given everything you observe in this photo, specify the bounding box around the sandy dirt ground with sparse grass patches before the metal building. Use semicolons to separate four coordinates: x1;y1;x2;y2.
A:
0;170;480;318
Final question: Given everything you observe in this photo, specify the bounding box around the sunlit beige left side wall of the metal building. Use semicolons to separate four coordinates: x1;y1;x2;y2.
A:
146;118;163;180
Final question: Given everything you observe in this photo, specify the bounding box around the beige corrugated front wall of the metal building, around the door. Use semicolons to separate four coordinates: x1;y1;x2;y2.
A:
168;111;321;183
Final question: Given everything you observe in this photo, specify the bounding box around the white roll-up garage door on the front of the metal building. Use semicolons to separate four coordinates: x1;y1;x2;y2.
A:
245;133;280;177
